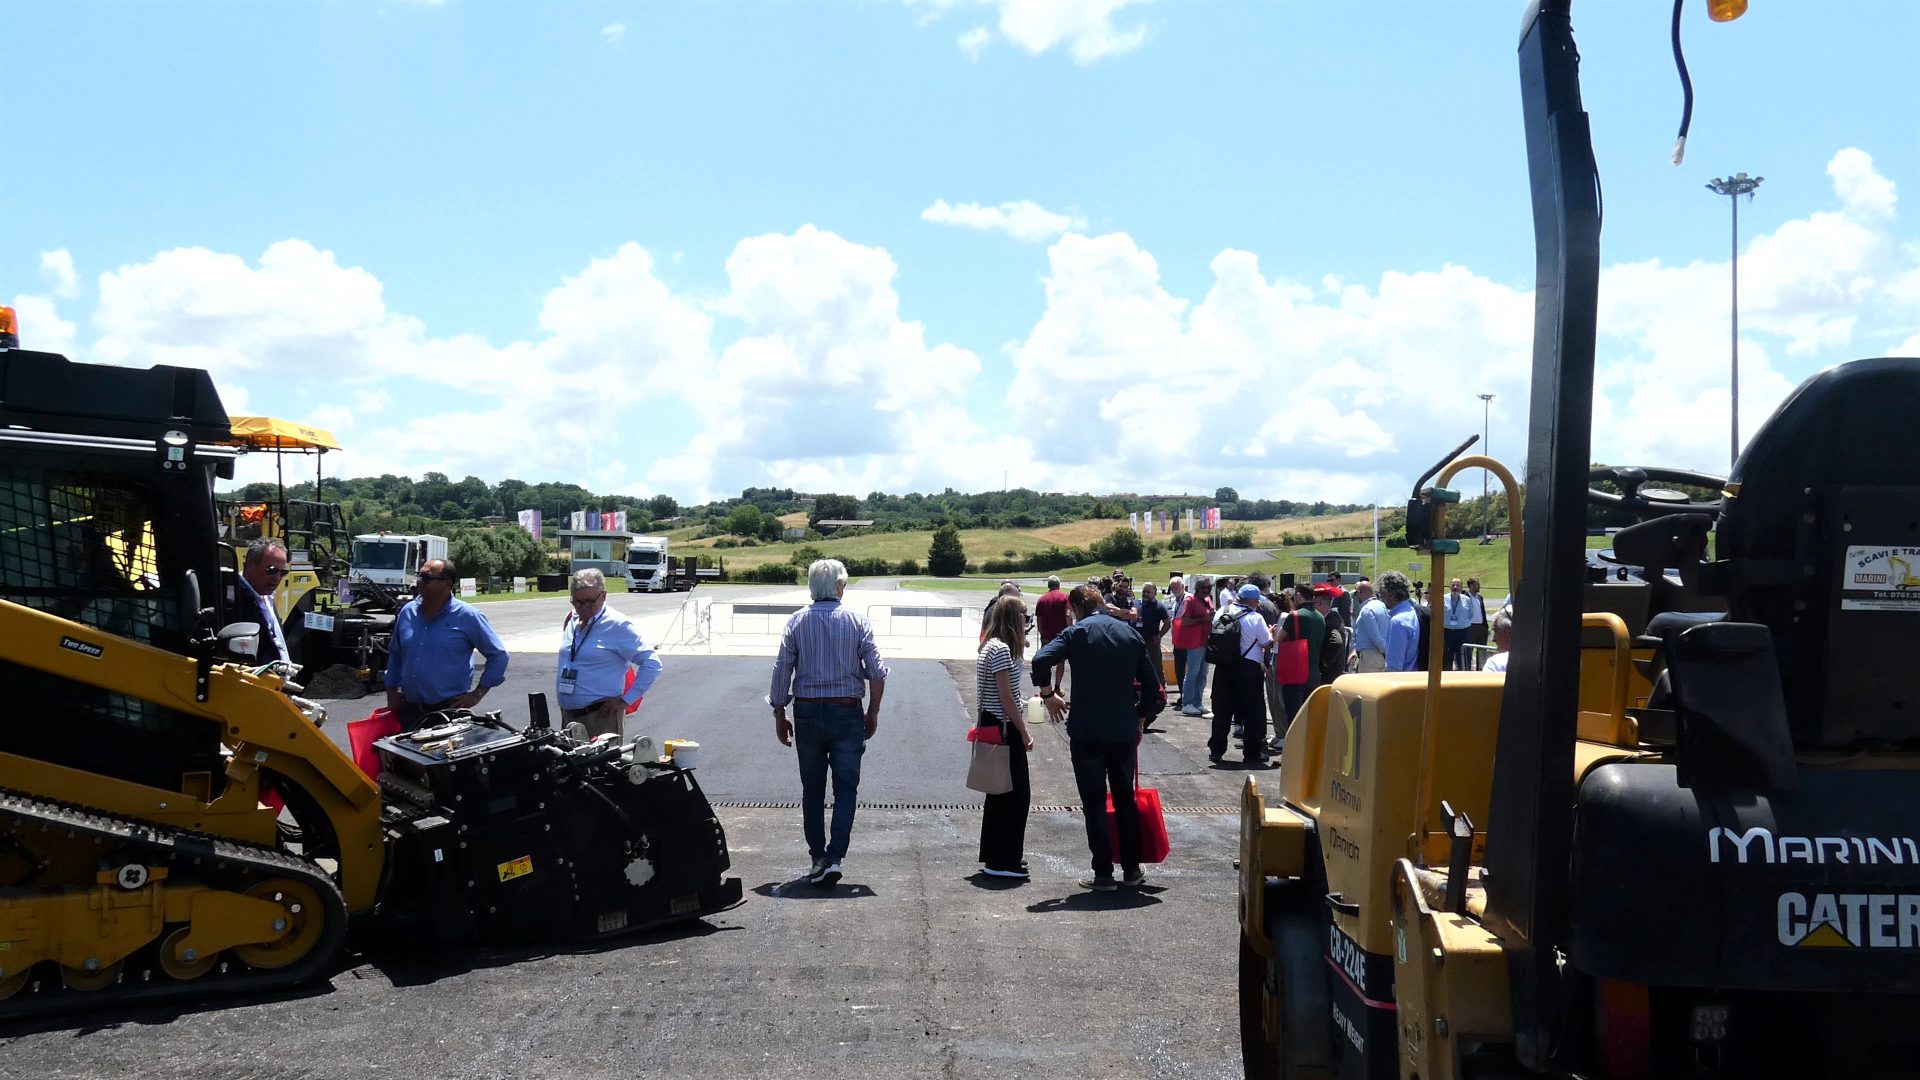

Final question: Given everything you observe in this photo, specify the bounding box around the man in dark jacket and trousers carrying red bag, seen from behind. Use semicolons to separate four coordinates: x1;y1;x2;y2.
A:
1033;584;1160;892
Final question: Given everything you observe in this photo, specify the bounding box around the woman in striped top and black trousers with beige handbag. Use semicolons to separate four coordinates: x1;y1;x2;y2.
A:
975;596;1033;880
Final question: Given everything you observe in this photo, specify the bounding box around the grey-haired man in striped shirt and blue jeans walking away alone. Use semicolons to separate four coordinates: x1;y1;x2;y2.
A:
766;559;887;888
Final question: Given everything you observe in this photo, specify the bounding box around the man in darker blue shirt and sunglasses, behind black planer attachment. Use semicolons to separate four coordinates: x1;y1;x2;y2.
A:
386;559;507;732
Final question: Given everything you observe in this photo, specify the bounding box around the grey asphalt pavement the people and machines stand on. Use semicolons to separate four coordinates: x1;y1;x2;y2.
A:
0;590;1242;1080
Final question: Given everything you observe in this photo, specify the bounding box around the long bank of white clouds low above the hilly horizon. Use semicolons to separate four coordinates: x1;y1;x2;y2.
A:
30;152;1920;502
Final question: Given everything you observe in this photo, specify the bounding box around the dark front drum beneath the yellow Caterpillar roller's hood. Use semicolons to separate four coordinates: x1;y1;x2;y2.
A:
1240;882;1332;1080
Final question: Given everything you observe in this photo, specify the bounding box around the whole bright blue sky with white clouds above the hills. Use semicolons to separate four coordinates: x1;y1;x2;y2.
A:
0;0;1920;502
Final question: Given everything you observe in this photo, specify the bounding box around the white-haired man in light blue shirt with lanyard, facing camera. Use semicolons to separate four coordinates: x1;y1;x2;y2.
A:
555;567;660;738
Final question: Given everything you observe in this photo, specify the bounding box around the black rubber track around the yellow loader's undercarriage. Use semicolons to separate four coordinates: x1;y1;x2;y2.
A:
0;788;348;1022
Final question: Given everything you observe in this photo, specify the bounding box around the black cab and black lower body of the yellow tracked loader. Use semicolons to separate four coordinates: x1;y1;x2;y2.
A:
0;350;238;786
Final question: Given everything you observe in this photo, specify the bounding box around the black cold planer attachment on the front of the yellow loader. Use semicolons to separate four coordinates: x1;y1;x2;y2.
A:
376;701;741;940
